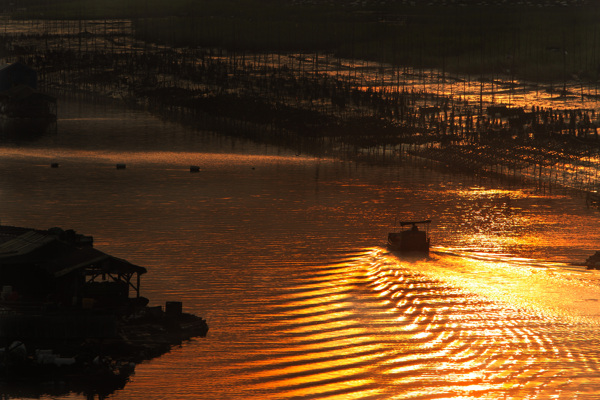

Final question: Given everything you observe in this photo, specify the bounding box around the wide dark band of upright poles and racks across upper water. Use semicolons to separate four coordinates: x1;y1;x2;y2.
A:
0;5;600;197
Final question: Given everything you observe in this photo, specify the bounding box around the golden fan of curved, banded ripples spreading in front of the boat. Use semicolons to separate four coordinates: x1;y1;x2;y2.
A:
219;249;600;399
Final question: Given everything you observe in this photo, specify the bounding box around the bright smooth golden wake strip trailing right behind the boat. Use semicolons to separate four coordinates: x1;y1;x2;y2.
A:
421;245;600;325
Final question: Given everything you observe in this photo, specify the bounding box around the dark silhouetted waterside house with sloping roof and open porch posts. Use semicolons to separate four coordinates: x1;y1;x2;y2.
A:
0;226;146;310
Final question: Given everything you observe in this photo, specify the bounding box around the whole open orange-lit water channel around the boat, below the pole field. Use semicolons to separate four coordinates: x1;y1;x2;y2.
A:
0;98;600;400
